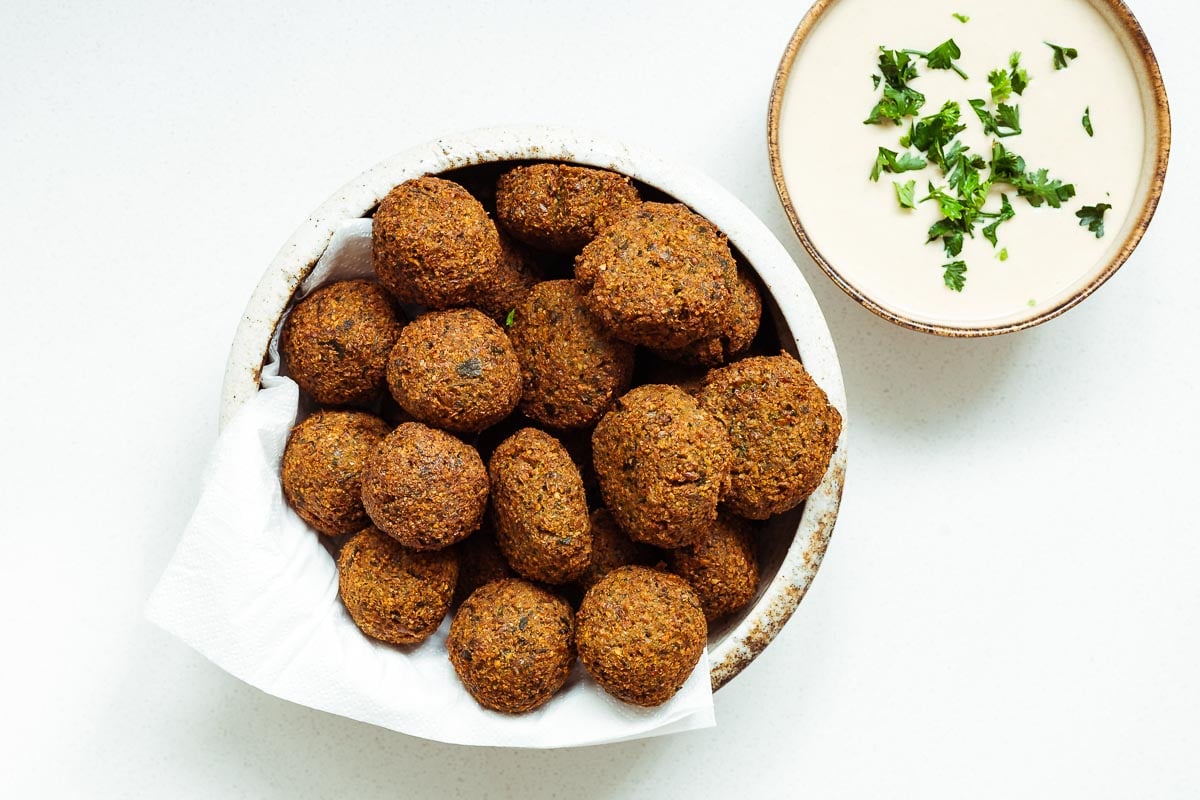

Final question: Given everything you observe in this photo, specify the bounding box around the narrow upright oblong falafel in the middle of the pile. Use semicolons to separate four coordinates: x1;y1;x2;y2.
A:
487;428;592;584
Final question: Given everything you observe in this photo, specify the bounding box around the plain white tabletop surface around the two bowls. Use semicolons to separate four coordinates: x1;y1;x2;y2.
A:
0;0;1200;798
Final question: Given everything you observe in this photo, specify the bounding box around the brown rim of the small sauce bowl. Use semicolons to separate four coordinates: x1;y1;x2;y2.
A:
767;0;1171;338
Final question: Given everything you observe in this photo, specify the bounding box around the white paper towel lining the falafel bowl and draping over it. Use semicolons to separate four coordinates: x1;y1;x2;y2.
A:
146;219;715;747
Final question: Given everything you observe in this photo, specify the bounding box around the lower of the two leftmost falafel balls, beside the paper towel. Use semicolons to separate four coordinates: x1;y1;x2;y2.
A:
280;411;391;536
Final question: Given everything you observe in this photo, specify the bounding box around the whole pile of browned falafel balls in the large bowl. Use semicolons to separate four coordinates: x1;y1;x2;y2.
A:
280;163;841;712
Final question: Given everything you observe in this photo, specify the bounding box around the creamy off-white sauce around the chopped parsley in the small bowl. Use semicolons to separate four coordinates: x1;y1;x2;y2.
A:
779;0;1145;326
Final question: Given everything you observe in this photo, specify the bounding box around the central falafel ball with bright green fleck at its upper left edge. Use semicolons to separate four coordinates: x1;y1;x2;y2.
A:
509;281;634;428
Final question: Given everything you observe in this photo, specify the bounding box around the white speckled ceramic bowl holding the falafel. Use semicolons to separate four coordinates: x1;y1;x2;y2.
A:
221;127;846;688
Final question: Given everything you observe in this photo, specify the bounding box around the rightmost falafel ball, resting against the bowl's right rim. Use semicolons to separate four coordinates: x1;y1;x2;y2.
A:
700;353;841;519
